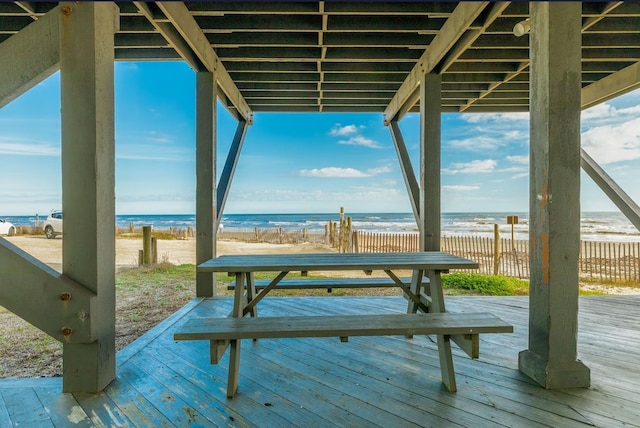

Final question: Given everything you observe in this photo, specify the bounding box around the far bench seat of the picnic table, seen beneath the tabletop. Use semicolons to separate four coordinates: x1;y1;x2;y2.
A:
227;277;429;290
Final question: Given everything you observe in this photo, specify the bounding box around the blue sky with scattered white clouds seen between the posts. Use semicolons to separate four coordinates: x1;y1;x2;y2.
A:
0;62;640;216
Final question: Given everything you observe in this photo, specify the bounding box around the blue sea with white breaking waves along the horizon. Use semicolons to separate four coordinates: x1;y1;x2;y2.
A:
0;212;640;242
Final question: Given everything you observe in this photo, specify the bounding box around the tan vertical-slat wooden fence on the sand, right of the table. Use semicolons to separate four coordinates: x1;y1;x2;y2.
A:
355;231;640;282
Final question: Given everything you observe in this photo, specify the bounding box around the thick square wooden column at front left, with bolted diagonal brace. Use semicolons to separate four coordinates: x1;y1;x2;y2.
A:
60;2;119;392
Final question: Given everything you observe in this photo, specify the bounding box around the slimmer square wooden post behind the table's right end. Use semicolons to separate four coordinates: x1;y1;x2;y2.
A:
419;73;442;251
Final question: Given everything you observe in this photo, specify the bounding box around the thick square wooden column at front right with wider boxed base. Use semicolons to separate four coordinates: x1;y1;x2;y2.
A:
519;2;590;389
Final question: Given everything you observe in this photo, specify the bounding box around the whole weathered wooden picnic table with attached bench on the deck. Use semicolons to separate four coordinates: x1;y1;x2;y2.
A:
174;252;513;398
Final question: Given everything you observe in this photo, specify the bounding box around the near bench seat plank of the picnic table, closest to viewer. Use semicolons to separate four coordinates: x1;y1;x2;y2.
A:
173;313;513;340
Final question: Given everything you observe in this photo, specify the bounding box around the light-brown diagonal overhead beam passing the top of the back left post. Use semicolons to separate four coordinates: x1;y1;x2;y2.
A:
157;2;253;124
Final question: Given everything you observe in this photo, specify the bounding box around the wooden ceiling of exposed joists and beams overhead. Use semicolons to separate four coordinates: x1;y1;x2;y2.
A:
0;1;640;118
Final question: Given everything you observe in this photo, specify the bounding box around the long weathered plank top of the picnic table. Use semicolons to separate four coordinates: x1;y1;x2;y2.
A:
198;251;478;272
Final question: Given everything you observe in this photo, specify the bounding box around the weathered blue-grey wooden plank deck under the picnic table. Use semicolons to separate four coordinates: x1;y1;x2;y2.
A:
0;296;640;428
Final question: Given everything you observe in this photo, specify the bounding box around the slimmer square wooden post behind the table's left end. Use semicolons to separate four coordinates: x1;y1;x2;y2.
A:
196;71;218;297
